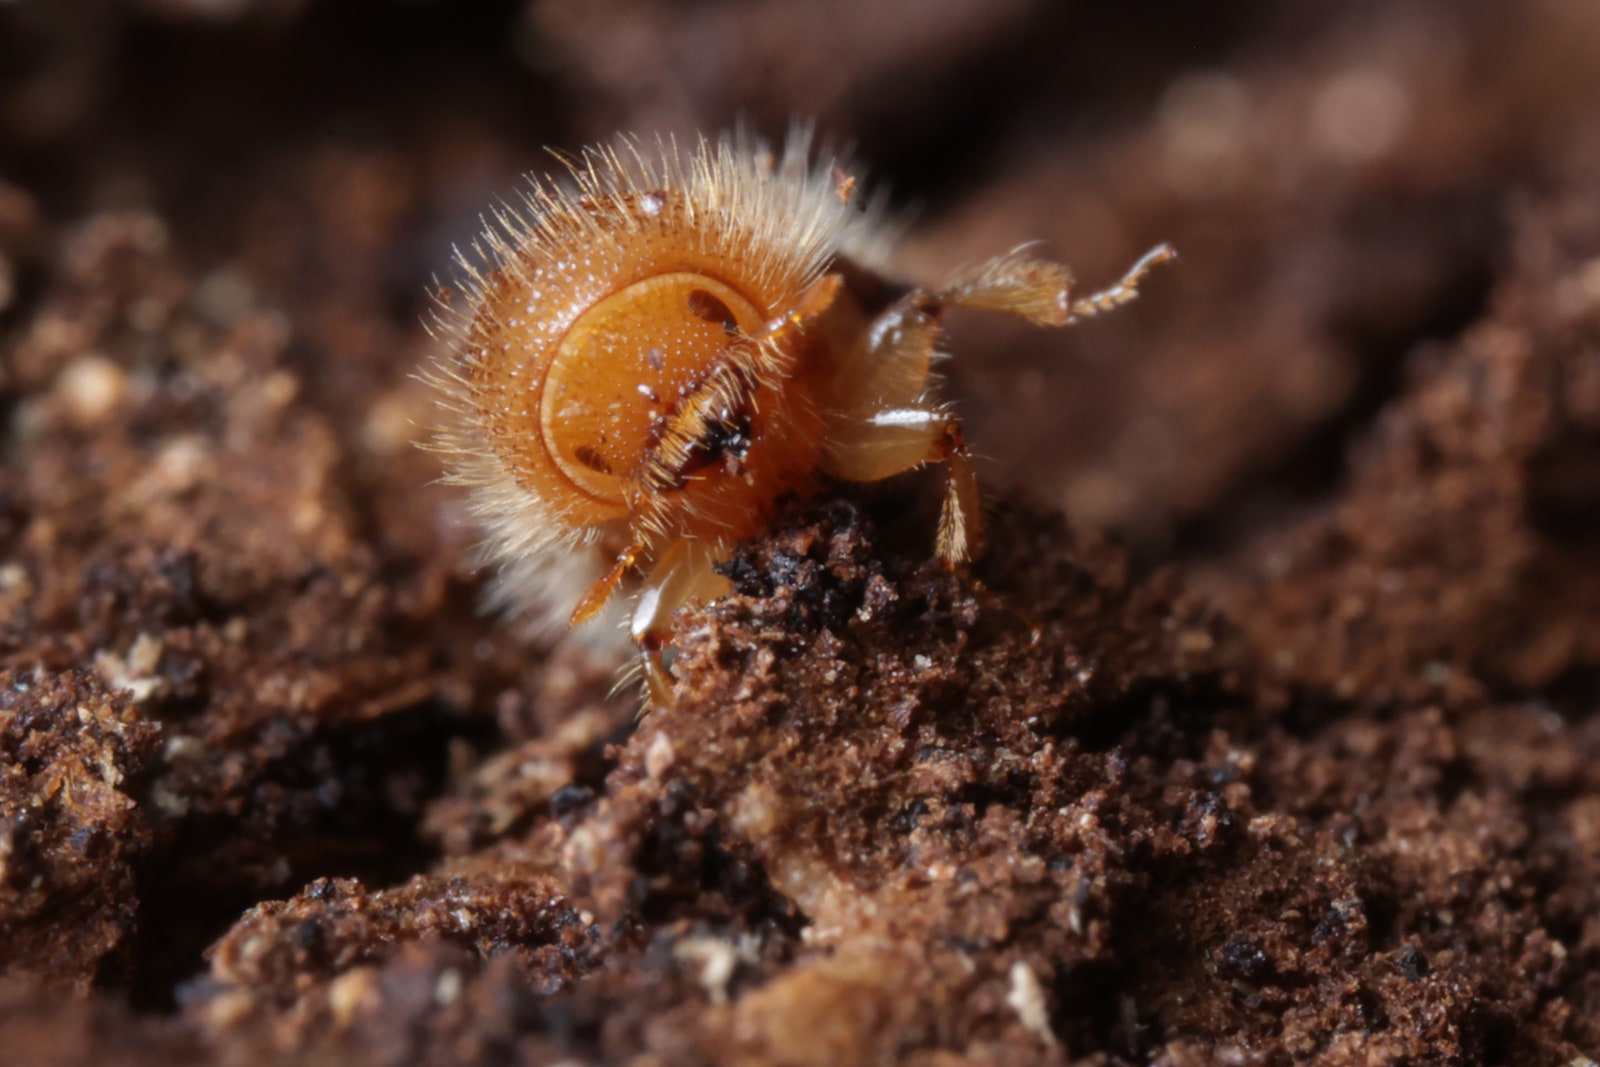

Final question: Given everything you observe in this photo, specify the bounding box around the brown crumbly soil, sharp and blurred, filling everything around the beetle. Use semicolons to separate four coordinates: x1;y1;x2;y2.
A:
0;0;1600;1067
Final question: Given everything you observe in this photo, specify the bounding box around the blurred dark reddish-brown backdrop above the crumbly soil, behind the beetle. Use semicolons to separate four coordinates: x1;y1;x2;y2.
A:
12;0;1600;558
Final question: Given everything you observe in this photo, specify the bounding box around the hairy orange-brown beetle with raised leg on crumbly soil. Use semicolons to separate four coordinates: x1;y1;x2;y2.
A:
432;129;1173;701
